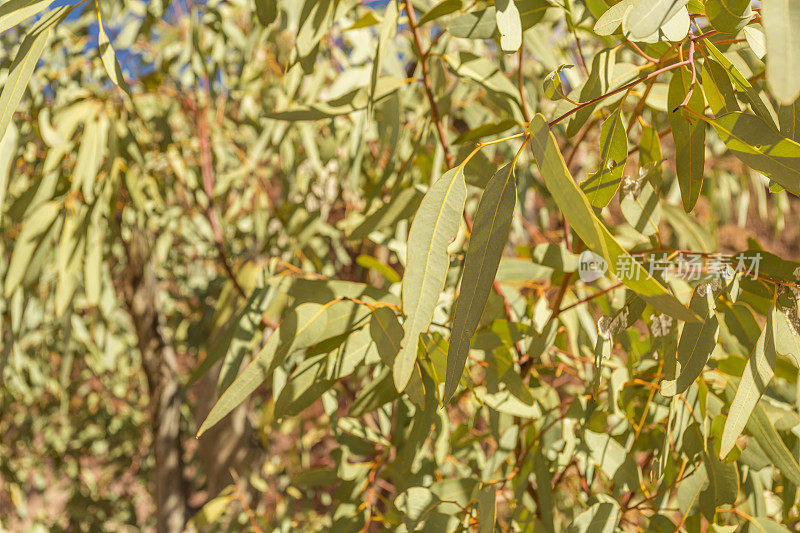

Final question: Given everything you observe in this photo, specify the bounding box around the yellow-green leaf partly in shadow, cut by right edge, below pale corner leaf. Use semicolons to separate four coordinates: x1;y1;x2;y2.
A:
707;111;800;195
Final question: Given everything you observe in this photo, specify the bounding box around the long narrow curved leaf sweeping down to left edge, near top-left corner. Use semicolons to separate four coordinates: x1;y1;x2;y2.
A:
0;4;73;139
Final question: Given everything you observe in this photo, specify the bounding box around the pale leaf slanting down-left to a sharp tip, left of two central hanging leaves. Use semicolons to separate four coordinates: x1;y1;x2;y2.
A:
197;302;338;437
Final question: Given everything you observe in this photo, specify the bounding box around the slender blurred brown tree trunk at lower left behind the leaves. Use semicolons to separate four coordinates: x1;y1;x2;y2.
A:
126;231;187;533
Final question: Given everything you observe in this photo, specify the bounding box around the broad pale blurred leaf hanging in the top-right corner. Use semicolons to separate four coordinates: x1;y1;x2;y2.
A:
761;0;800;105
